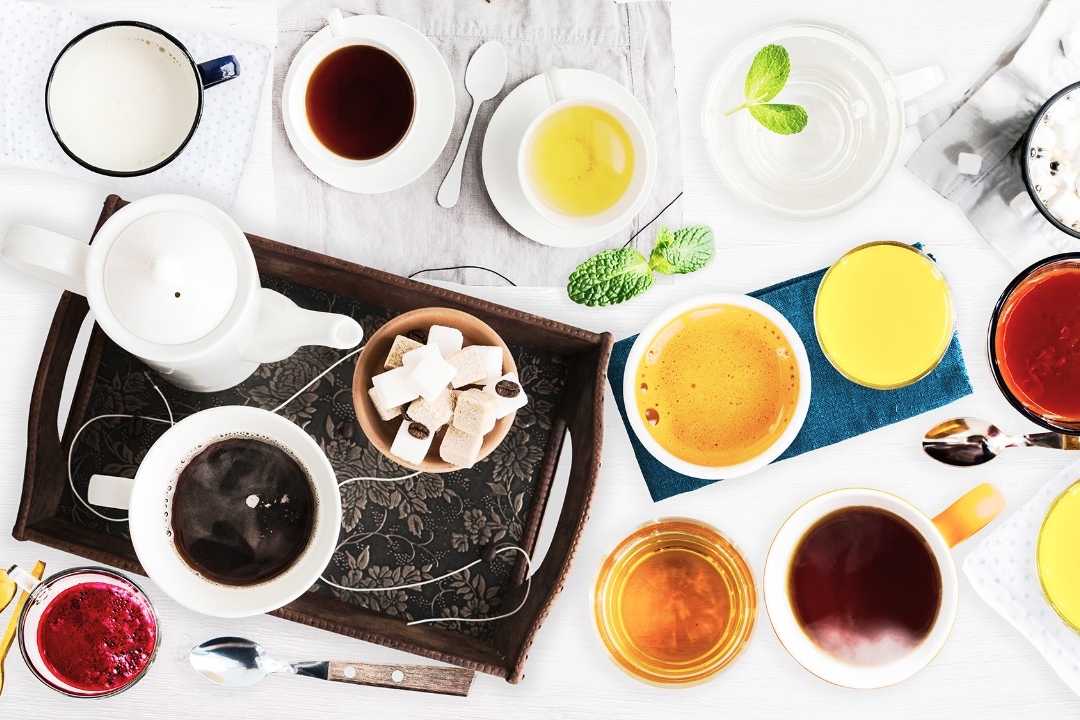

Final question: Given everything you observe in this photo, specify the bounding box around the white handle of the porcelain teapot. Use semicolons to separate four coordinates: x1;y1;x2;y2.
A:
0;225;90;295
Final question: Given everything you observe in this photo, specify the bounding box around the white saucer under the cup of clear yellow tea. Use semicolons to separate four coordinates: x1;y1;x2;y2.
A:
482;69;657;247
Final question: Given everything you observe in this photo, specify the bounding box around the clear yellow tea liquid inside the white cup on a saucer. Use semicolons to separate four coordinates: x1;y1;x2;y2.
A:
528;105;634;217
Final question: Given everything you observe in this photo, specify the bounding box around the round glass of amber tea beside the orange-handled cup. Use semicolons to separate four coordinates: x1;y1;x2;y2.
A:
594;520;757;684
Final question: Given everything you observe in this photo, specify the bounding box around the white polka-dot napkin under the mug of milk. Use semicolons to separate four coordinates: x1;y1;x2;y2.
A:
0;0;270;208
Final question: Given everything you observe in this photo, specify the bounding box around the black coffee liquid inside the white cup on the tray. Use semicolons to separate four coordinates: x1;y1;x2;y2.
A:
171;437;316;585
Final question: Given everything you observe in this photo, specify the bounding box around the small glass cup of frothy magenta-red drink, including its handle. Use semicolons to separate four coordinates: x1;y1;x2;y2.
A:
9;566;160;697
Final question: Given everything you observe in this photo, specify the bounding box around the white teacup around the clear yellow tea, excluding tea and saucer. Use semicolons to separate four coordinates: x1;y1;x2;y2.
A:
517;68;656;230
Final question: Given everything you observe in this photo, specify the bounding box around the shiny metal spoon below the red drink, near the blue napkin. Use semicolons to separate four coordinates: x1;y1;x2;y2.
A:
922;418;1080;467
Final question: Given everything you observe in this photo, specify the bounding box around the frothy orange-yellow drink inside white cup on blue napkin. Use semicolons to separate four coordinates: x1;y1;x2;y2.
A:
635;304;799;467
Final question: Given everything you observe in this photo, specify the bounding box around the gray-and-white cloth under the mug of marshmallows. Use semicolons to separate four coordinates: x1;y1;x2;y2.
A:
907;0;1080;269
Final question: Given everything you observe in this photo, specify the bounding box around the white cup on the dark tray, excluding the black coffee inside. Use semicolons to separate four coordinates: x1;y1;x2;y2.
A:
89;406;341;617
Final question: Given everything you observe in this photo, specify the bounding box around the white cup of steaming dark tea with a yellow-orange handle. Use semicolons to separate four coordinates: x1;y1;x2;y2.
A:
764;485;1004;688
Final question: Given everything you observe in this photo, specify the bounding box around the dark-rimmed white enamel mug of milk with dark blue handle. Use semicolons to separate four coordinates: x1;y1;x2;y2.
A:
45;21;240;177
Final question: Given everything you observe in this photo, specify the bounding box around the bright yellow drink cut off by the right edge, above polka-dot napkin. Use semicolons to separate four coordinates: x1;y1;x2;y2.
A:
1035;481;1080;633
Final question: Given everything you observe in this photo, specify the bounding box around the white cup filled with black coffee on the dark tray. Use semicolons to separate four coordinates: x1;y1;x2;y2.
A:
87;405;341;617
